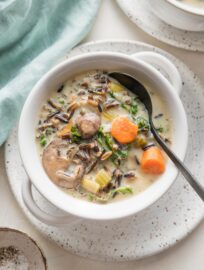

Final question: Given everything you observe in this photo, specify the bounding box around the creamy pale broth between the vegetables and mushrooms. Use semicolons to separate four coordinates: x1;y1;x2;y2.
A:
36;70;172;203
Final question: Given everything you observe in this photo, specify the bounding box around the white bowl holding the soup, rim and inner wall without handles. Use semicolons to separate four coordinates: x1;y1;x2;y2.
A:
18;52;188;222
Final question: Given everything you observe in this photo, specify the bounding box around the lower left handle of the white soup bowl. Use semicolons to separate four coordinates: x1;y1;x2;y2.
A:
21;180;80;226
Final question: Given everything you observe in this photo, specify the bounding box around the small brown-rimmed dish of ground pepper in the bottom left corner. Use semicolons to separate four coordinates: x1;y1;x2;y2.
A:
0;228;47;270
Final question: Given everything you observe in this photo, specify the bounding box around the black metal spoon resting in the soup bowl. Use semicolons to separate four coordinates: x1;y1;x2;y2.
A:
108;72;204;201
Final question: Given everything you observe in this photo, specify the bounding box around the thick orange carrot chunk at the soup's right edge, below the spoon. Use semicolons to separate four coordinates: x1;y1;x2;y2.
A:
141;146;165;174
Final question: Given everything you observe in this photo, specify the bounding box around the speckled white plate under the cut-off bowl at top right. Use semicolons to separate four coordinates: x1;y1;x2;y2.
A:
117;0;204;52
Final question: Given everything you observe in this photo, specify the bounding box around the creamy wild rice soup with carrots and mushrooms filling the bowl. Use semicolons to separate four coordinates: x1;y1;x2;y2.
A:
36;70;172;203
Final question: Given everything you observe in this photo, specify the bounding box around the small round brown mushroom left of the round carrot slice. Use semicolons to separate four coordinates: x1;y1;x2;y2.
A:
76;112;101;139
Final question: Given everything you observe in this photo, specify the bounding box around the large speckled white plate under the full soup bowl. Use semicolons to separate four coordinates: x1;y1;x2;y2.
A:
5;41;204;261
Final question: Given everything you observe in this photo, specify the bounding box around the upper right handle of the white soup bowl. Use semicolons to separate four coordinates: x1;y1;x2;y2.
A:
132;51;182;95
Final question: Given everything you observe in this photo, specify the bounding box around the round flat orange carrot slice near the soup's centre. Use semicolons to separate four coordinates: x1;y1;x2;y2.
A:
111;116;138;144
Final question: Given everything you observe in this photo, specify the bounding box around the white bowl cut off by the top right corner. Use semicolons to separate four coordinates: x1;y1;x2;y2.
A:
148;0;204;32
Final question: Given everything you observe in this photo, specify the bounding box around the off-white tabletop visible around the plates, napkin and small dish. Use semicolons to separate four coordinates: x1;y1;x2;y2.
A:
0;0;204;270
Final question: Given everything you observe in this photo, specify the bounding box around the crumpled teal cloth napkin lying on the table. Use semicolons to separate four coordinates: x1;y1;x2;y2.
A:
0;0;100;145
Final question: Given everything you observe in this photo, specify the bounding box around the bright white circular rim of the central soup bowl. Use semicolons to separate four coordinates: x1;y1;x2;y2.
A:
18;52;188;220
